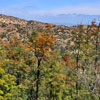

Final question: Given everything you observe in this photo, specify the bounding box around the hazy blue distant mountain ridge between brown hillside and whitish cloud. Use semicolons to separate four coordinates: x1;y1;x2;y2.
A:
33;13;100;26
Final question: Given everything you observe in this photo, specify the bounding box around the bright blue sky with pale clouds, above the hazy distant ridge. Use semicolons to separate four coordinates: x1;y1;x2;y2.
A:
0;0;100;19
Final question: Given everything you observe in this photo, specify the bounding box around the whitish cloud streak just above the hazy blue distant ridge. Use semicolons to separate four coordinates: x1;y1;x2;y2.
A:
30;6;100;15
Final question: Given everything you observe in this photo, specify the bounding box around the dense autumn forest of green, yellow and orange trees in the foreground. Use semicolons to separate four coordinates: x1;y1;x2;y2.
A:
0;22;100;100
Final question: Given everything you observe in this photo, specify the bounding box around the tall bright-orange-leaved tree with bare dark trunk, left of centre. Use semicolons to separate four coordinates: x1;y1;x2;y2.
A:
28;28;55;100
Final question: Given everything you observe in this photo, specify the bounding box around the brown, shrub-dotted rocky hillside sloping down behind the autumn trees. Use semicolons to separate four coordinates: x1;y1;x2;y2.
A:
0;14;72;52
